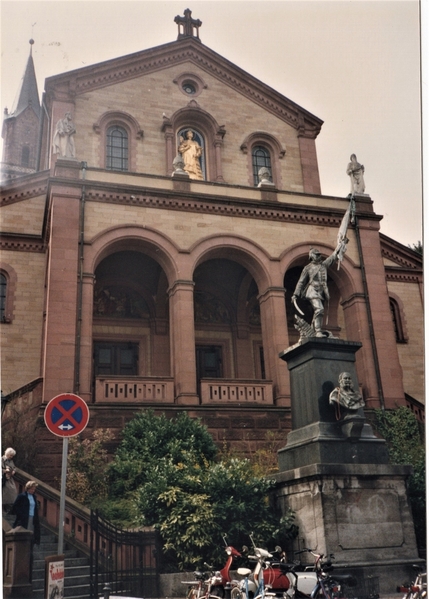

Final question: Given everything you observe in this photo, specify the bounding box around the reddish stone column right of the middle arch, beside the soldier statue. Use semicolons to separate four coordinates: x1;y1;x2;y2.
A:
258;287;290;406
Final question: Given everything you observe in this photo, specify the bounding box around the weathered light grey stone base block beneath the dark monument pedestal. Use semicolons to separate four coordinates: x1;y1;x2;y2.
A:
274;463;419;593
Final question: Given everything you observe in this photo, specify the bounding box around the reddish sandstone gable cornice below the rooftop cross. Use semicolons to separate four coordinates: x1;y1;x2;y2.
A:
45;37;323;139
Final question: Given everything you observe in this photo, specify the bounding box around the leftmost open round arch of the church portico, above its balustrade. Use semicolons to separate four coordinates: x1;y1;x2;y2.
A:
92;247;170;377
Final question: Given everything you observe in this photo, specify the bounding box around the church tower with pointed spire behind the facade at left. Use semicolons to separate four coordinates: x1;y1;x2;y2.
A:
1;39;41;180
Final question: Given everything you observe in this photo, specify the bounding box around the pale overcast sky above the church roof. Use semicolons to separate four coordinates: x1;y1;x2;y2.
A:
1;0;422;245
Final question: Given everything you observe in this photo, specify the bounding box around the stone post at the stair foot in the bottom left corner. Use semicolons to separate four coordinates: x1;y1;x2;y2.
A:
3;526;33;599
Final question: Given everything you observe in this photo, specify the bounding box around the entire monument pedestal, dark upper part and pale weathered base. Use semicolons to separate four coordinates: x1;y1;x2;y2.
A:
275;338;418;593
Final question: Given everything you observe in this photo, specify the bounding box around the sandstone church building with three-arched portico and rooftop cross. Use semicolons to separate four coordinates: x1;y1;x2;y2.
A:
0;10;424;482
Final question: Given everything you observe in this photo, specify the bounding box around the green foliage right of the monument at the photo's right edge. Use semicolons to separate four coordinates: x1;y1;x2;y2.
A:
375;406;426;553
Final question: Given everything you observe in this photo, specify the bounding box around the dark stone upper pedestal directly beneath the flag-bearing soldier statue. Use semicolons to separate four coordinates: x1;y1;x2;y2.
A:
278;337;388;471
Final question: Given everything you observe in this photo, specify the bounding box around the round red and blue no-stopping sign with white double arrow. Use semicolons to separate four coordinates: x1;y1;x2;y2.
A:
44;393;89;437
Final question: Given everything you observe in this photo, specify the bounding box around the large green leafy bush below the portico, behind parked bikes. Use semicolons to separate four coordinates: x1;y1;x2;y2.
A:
106;411;297;570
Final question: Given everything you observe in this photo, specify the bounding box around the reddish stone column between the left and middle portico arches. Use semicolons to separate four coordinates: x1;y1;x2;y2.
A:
168;280;199;405
